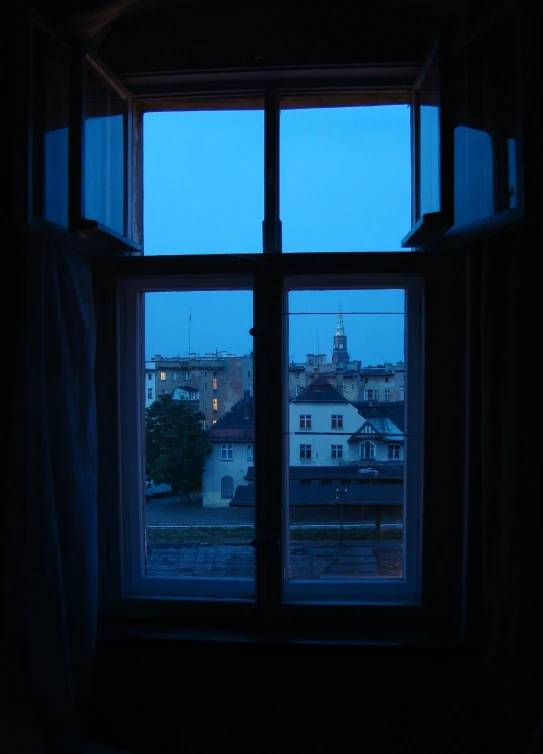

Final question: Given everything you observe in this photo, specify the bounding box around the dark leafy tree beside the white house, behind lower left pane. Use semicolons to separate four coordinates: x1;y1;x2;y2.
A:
145;395;211;497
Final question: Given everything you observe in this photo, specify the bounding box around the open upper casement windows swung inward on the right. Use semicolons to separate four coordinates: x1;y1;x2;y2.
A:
402;10;524;248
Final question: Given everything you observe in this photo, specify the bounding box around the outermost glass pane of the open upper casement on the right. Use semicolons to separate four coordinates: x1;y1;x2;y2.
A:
454;21;516;227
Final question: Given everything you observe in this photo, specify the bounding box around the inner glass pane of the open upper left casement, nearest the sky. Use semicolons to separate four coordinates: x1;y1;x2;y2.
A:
84;63;126;235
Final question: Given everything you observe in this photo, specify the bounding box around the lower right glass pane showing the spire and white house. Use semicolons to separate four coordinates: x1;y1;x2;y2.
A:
286;289;405;599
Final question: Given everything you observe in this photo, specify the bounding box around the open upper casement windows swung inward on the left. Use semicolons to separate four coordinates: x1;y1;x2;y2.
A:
25;11;142;253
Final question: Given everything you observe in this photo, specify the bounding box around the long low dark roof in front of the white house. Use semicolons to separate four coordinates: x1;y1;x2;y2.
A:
229;482;403;507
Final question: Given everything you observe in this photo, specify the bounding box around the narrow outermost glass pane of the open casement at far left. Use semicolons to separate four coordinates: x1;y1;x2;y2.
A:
32;27;70;227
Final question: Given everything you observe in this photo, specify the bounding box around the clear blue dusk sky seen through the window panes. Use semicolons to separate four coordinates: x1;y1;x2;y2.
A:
144;105;411;364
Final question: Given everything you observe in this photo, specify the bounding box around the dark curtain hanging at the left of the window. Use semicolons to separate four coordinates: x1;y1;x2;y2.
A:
4;237;98;739
